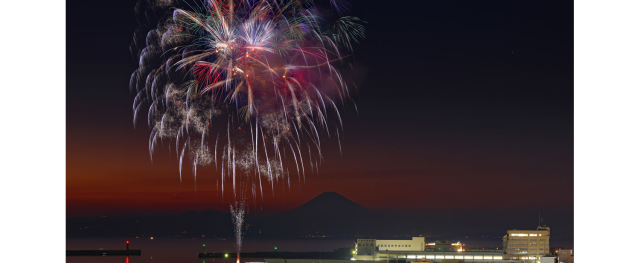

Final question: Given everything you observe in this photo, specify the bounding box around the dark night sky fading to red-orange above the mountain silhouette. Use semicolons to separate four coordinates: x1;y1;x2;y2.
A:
66;0;574;227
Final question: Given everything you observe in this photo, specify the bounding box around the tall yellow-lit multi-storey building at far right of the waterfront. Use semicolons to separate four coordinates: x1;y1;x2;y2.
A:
502;226;551;261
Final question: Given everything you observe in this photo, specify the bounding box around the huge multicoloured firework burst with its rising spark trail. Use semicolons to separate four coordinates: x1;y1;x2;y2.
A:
130;0;365;256
